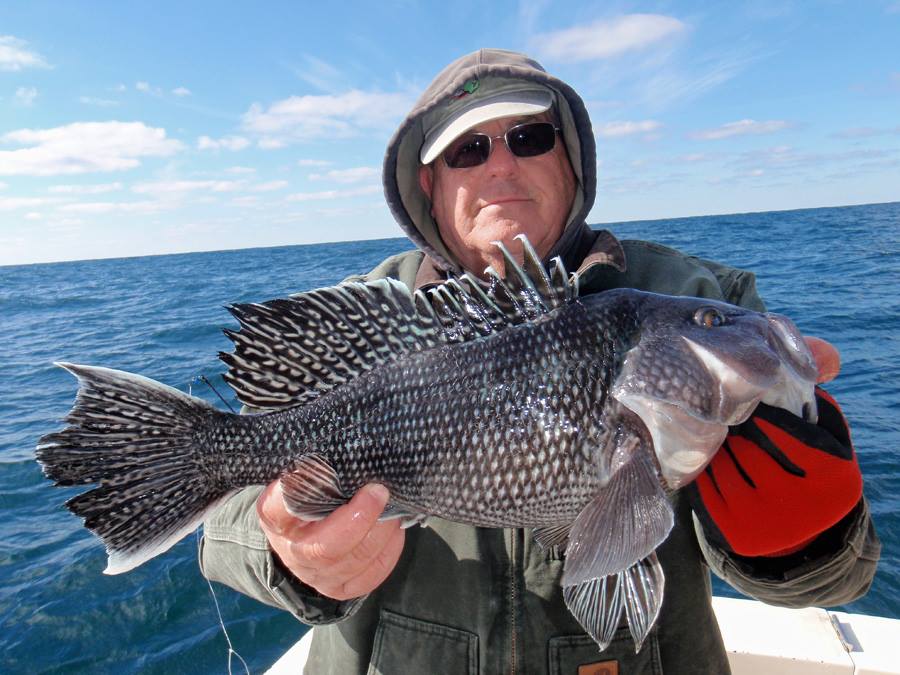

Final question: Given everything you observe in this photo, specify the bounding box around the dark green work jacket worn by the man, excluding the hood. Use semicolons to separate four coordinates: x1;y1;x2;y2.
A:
201;228;880;675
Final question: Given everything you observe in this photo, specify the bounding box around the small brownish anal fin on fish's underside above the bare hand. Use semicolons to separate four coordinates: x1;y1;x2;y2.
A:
281;454;350;520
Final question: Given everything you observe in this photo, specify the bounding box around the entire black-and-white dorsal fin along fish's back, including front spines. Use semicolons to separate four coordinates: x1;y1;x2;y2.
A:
219;236;577;410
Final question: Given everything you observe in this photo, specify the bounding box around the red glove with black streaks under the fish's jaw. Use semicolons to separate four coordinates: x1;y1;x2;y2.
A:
688;387;862;557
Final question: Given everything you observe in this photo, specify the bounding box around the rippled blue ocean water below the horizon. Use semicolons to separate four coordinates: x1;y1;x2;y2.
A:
0;203;900;673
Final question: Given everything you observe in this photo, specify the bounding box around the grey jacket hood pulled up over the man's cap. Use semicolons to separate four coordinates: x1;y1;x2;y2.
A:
382;49;597;271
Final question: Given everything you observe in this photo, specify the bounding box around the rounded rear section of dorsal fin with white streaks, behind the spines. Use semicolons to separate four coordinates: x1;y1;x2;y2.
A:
219;279;446;410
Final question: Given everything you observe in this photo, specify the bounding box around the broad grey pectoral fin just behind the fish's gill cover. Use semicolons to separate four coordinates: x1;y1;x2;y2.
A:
562;450;674;586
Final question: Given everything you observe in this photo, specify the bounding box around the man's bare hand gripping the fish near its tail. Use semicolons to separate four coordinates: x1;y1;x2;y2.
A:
256;480;405;600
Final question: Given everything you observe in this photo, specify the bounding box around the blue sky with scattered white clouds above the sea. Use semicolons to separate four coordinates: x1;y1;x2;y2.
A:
0;0;900;265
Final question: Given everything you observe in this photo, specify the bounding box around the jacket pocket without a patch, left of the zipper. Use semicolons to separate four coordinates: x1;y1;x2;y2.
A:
367;609;478;675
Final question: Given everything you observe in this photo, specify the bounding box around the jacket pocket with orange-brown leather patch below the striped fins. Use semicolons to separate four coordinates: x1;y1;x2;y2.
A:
547;627;663;675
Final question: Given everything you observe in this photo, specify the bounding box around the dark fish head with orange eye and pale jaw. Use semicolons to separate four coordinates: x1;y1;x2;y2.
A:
610;293;816;489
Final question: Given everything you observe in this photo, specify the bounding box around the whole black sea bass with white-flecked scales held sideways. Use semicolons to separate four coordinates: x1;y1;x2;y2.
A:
36;237;816;650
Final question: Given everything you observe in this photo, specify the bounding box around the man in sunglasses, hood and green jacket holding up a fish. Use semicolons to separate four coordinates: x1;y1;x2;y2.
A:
201;50;880;673
